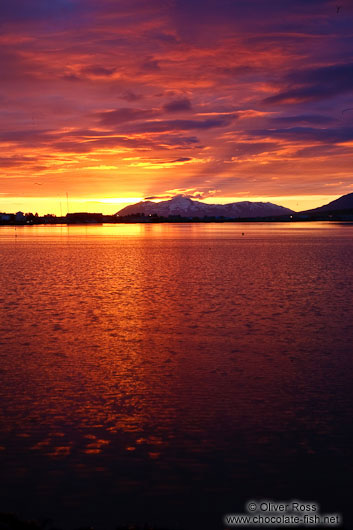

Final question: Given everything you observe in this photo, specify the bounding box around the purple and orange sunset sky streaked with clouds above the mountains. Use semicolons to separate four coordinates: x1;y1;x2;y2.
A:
0;0;353;215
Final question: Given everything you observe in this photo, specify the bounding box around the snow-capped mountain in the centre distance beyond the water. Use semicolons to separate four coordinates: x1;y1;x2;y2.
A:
116;195;293;218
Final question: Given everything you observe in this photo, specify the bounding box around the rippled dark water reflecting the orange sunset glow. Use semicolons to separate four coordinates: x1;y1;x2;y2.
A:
0;223;353;530
